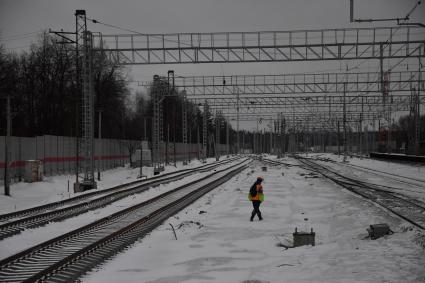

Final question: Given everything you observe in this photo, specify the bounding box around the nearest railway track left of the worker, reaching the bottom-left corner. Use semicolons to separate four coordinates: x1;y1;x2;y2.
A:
0;160;250;282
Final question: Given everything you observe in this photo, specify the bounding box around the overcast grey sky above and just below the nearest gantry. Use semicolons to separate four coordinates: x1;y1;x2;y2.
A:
0;0;425;130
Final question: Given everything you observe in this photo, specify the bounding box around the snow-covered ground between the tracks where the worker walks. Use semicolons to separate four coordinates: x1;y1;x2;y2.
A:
83;160;425;283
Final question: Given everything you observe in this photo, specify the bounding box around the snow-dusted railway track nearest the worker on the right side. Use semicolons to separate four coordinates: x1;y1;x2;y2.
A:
264;156;425;230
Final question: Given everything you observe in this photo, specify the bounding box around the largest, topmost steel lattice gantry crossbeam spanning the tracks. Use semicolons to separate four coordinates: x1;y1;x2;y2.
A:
95;26;425;65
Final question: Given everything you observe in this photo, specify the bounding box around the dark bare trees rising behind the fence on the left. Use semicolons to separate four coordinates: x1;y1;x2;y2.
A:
0;32;234;150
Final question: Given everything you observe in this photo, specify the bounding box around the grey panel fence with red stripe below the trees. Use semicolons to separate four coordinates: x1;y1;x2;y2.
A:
0;135;226;183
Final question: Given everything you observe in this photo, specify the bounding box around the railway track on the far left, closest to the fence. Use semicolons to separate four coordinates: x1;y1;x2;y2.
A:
0;158;235;240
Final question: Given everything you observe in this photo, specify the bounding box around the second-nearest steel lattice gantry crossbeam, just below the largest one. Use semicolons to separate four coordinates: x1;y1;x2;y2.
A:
171;71;418;96
